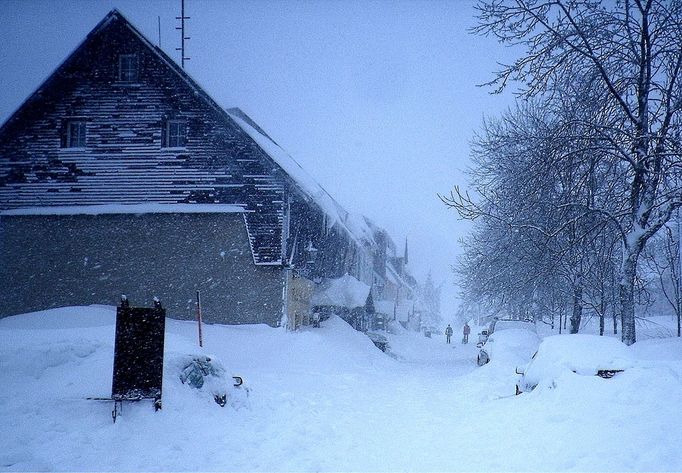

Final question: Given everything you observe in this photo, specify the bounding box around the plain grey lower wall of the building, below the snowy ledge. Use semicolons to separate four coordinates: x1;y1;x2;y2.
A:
0;213;283;326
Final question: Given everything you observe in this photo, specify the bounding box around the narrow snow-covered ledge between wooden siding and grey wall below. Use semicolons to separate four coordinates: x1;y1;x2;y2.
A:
0;203;246;215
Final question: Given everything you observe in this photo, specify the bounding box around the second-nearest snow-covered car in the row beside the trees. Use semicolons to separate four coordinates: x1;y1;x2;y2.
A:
476;324;540;366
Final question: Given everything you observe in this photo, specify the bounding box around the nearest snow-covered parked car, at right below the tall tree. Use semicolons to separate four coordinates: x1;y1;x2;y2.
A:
516;334;634;394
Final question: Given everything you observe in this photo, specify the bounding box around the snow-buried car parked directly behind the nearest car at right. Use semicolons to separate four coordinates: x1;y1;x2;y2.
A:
476;319;539;366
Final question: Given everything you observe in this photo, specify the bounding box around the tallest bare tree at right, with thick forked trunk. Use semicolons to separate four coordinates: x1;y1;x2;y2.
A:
460;0;682;344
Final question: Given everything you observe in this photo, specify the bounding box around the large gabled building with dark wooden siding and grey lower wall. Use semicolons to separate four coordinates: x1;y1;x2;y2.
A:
0;10;410;326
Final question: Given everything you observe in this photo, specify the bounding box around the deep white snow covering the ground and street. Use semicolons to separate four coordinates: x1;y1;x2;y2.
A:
0;306;682;471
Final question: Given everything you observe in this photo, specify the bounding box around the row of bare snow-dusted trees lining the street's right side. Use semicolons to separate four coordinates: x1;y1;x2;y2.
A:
441;0;682;344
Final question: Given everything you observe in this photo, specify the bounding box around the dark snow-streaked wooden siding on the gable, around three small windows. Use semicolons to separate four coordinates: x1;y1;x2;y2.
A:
0;12;288;265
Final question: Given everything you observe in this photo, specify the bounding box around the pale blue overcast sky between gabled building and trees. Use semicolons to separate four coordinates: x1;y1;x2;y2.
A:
0;0;511;321
